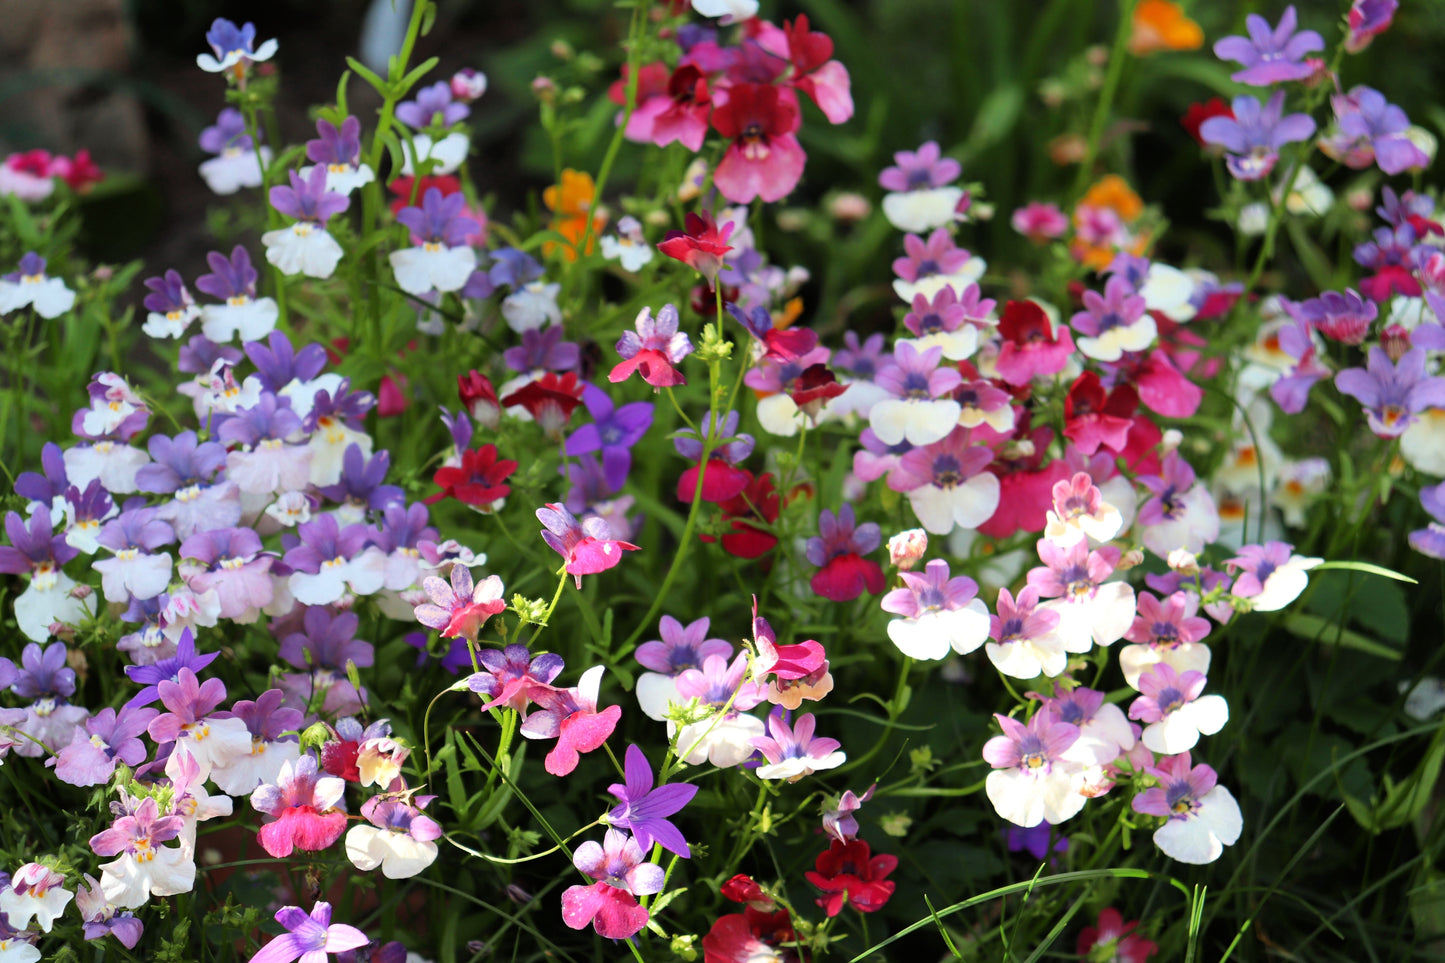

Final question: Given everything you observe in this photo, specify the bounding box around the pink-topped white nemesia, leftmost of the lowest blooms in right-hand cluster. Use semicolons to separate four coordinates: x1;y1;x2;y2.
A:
984;709;1087;829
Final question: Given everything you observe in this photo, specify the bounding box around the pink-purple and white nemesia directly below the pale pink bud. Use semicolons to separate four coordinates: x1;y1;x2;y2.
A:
879;558;988;659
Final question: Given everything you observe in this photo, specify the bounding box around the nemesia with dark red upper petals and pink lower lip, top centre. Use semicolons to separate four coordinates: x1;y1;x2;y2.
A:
713;84;808;203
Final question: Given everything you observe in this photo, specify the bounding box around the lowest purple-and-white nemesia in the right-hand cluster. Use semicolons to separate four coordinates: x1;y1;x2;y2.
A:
1133;752;1244;865
